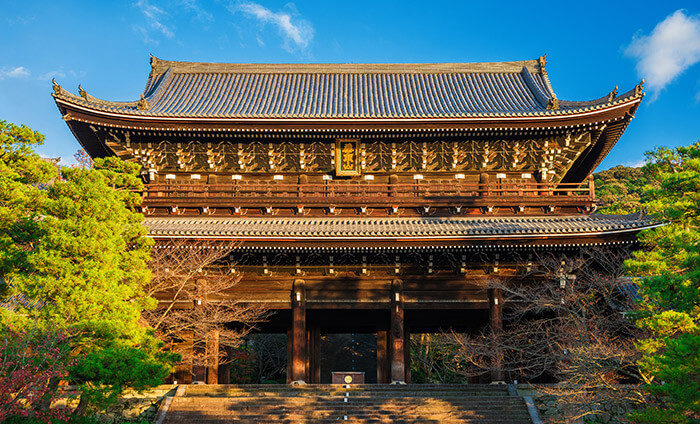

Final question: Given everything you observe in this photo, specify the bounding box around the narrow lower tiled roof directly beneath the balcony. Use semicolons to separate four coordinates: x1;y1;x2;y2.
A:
145;214;656;240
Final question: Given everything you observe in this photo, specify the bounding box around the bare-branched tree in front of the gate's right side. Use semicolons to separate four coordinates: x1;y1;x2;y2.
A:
447;249;643;422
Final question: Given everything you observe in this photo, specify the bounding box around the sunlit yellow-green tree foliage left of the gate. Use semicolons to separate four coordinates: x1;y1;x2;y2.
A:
0;122;174;418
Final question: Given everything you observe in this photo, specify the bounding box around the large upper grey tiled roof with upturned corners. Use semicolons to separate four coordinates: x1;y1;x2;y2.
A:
54;58;641;119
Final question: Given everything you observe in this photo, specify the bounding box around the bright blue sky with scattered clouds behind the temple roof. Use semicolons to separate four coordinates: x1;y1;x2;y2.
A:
0;0;700;169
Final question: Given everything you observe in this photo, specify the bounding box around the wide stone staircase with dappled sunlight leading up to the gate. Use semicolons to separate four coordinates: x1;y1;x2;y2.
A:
159;384;532;424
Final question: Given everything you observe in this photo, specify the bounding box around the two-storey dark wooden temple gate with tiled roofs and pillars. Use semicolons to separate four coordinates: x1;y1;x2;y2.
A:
53;57;652;383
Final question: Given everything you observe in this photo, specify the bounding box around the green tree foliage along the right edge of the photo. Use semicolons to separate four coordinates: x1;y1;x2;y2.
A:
627;142;700;423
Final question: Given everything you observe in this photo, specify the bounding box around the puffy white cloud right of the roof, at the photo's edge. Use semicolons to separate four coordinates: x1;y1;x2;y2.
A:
625;9;700;100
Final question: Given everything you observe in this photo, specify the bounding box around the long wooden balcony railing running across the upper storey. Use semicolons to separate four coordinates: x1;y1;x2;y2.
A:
143;176;595;207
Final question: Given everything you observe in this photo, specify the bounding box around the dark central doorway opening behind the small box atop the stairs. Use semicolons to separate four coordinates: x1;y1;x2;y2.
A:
320;333;377;384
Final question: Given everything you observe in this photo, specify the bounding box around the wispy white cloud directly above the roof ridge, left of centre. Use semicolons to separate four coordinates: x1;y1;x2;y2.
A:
232;3;314;51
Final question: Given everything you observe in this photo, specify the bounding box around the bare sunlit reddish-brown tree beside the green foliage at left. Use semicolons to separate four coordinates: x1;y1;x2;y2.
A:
143;239;269;365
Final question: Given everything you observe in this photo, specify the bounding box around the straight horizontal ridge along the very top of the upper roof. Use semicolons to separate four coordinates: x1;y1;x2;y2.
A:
151;56;543;77
